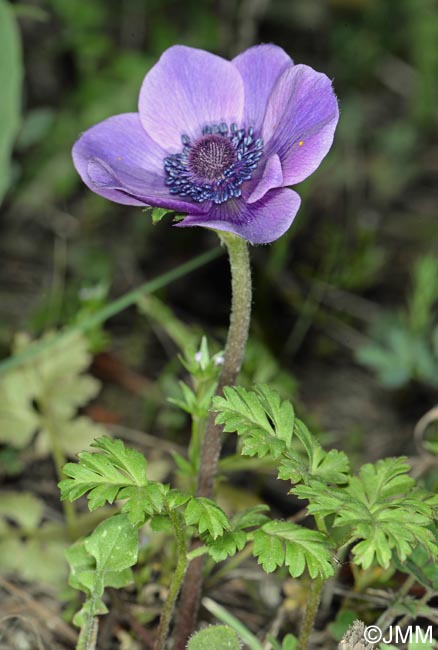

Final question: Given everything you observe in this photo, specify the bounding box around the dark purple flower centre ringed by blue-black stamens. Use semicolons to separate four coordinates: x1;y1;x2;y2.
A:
164;123;263;204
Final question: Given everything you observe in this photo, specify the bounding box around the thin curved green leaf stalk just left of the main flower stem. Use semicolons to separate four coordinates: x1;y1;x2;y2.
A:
155;508;189;650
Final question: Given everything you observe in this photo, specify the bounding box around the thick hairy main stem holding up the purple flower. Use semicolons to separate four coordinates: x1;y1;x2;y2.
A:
174;232;251;650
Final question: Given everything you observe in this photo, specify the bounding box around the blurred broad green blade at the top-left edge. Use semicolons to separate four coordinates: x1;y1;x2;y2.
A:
0;0;23;204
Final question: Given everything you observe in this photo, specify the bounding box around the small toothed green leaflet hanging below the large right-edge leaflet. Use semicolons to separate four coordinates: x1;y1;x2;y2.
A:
254;520;333;579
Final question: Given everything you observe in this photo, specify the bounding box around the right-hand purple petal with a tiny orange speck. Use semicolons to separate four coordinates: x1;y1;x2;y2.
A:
262;65;339;185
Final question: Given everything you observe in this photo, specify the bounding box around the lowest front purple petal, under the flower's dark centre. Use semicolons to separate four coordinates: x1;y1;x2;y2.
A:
175;188;301;244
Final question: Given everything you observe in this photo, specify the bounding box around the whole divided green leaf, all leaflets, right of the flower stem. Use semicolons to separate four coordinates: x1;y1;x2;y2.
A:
213;386;438;577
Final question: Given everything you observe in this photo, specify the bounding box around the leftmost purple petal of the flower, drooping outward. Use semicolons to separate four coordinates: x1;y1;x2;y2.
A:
73;113;208;213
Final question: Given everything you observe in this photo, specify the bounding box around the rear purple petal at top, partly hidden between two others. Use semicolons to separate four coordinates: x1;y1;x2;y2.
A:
232;44;293;130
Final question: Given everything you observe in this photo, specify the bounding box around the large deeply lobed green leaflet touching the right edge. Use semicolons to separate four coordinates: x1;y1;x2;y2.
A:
291;458;438;569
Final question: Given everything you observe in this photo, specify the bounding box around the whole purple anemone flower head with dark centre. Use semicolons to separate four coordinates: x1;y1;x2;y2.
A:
73;45;339;244
